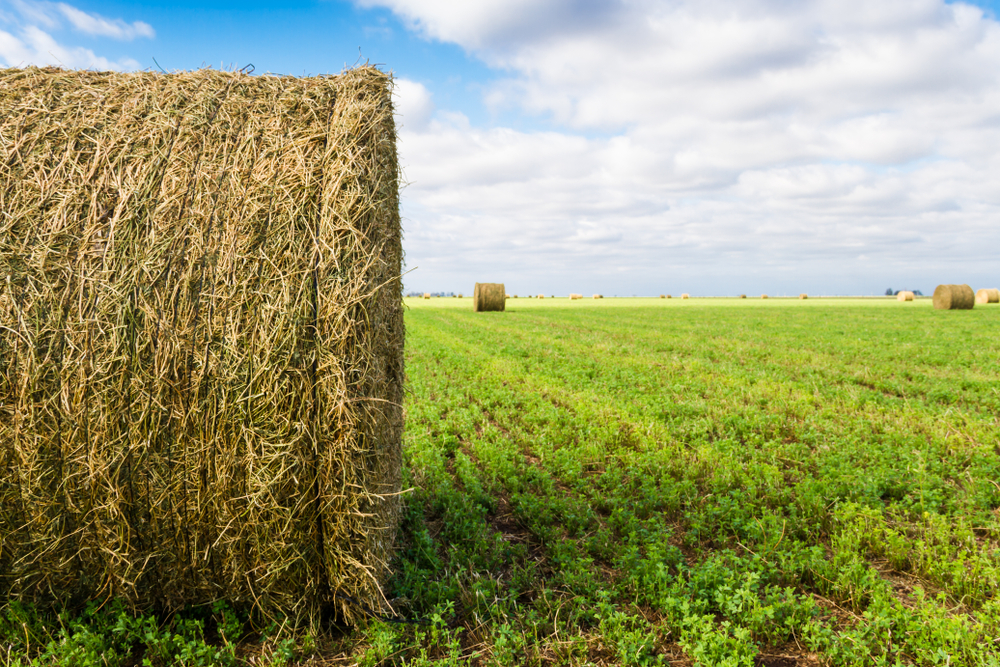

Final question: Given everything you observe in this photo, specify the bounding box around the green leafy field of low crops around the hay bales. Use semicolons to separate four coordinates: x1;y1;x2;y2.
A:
0;298;1000;667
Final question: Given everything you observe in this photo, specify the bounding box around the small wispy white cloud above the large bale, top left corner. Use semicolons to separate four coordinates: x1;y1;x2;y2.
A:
0;0;155;70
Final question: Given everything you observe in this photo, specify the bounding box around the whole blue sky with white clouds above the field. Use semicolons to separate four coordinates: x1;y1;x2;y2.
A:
0;0;1000;296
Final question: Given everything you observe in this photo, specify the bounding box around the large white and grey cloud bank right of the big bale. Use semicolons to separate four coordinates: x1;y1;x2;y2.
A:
372;0;1000;292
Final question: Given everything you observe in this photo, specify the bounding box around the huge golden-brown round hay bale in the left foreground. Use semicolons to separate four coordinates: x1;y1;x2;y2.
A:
0;67;404;623
